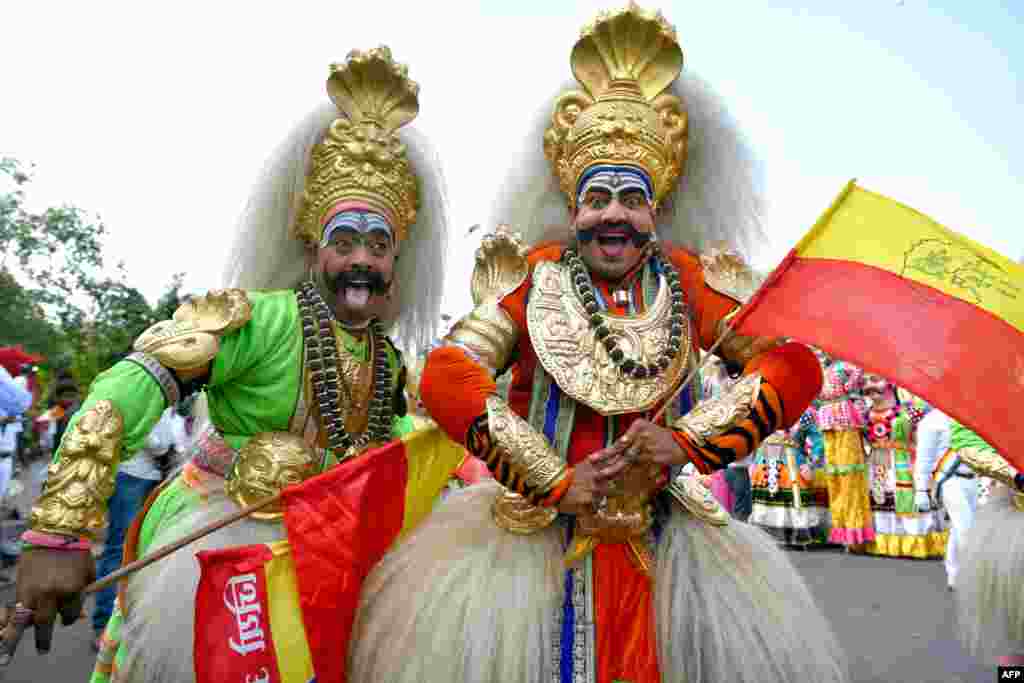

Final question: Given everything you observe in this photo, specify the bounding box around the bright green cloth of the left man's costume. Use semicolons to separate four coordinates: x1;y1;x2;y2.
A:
83;291;413;683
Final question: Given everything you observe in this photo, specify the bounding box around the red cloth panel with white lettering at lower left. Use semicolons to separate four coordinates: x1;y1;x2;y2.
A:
194;545;282;683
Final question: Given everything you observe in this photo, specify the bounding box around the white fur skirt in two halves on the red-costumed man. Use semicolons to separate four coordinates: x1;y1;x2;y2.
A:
349;482;847;683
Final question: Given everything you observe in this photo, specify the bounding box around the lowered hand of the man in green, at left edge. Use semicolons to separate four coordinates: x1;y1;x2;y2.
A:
0;548;96;666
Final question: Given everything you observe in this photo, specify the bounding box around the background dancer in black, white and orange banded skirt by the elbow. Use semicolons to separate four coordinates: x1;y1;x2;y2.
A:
751;409;824;547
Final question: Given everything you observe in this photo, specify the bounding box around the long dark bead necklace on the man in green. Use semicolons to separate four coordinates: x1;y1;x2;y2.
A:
296;281;394;460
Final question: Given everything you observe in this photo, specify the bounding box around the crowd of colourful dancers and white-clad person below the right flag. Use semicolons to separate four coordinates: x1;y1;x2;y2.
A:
702;350;993;589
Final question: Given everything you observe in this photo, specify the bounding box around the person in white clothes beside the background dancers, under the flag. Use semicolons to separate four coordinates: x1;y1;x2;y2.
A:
913;409;978;590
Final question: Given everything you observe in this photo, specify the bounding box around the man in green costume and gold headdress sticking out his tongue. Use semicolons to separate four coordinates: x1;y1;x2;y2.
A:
5;47;446;683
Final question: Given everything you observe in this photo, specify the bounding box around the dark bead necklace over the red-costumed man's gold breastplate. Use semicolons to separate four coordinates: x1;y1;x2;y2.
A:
563;245;686;379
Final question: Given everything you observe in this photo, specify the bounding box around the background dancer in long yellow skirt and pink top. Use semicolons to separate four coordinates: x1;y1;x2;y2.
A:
817;351;874;550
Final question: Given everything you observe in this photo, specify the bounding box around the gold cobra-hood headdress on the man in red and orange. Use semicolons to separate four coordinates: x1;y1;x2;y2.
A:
544;2;686;209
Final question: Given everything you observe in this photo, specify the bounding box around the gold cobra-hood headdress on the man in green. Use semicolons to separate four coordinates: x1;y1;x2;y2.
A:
293;47;420;244
